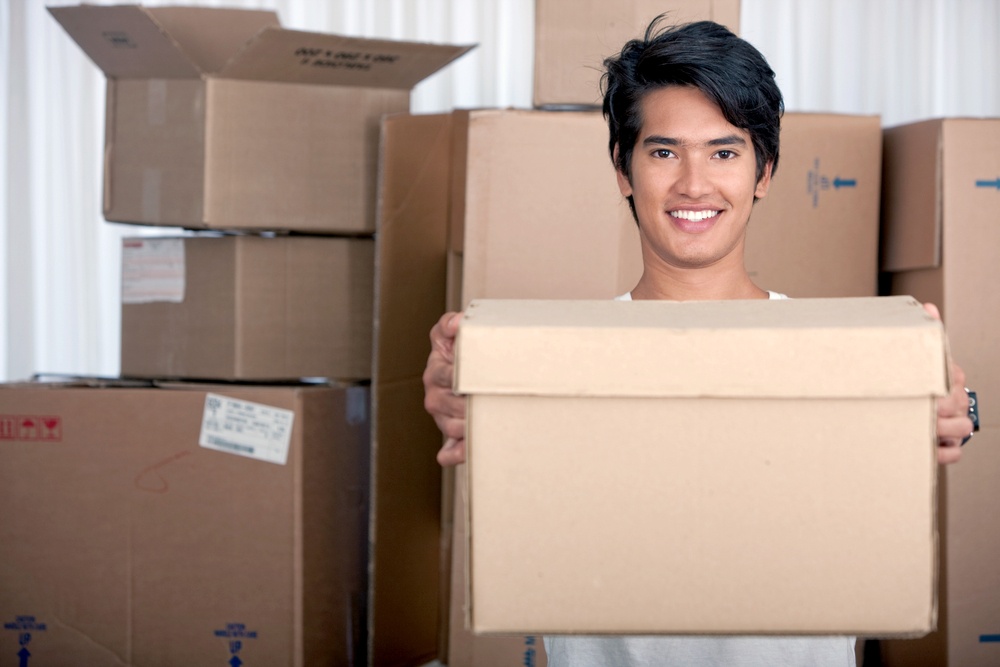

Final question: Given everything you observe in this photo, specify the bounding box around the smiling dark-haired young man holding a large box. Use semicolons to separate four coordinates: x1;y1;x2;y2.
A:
424;17;972;667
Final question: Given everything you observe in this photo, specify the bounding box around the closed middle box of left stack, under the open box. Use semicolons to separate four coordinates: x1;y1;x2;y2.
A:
121;235;375;381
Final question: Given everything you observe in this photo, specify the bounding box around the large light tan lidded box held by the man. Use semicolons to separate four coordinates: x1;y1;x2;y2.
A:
456;297;948;635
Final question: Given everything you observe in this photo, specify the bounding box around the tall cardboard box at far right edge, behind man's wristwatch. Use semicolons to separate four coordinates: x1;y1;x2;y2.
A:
882;118;1000;667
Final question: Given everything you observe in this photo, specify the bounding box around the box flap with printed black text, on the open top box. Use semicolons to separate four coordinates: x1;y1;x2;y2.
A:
220;28;474;90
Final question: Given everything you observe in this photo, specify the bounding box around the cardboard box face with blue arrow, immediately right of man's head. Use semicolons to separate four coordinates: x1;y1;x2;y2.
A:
746;113;882;298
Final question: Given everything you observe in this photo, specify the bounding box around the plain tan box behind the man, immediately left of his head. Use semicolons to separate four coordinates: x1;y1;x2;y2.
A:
450;111;642;305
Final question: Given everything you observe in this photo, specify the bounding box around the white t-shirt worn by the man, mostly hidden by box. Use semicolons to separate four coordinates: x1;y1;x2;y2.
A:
545;292;856;667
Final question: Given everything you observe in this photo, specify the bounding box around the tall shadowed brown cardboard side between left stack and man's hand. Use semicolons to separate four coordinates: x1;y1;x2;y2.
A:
367;114;451;665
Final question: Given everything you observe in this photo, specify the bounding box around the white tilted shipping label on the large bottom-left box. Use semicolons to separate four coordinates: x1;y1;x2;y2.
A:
198;394;295;465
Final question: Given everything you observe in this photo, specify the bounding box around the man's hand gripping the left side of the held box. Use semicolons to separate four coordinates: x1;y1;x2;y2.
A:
423;313;465;466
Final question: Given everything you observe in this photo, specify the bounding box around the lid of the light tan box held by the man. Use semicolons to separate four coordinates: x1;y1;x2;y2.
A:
455;297;948;398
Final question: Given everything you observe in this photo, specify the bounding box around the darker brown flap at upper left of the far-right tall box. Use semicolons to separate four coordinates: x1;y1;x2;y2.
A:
881;120;942;271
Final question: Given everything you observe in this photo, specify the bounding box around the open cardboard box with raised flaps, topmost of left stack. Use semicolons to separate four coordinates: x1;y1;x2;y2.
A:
49;5;469;233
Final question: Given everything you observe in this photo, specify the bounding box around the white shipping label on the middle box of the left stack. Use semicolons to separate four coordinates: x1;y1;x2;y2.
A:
122;238;185;304
